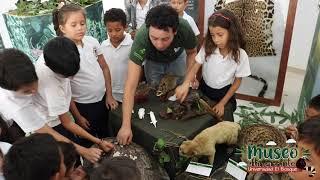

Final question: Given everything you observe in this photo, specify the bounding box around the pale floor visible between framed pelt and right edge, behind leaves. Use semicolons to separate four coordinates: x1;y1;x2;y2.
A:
235;67;305;127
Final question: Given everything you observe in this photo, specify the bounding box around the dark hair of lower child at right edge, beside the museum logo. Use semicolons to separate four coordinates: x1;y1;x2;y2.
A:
298;117;320;153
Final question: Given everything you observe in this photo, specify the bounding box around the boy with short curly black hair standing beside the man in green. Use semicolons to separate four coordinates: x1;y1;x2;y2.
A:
101;8;133;102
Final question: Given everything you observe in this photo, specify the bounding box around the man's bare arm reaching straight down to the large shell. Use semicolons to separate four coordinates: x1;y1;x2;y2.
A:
117;60;142;144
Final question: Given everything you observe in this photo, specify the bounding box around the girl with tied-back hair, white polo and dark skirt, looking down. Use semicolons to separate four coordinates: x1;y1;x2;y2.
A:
53;4;118;147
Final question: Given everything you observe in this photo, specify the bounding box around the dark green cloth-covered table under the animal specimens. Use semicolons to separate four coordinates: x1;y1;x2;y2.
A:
109;95;233;177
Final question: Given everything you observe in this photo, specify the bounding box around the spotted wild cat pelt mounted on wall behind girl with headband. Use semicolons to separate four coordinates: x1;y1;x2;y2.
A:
215;0;276;57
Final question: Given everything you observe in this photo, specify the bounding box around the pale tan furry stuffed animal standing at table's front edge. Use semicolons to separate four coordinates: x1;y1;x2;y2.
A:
179;121;241;164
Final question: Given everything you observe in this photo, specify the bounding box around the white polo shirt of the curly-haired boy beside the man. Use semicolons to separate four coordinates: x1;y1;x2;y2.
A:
101;33;133;102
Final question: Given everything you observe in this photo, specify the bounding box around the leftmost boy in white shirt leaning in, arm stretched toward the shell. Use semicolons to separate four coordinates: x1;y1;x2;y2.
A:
0;49;105;162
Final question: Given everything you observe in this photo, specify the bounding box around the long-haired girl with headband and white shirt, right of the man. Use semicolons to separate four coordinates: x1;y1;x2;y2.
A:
176;9;251;121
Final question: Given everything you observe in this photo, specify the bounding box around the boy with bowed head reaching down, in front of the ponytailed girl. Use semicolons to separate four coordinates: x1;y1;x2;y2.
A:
34;37;113;160
